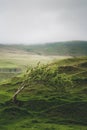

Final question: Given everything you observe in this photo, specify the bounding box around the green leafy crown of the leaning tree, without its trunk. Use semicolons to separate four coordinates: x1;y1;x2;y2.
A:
28;65;72;92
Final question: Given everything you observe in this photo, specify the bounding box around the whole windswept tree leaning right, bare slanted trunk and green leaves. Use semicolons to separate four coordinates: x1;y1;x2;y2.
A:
13;63;72;102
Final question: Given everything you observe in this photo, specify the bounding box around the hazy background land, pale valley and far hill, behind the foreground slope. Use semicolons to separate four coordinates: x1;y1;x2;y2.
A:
0;41;87;81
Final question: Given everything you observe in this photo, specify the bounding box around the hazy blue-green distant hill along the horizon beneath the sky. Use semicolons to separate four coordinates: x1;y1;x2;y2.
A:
0;41;87;56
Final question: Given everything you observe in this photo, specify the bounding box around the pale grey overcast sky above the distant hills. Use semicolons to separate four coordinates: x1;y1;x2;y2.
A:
0;0;87;44
